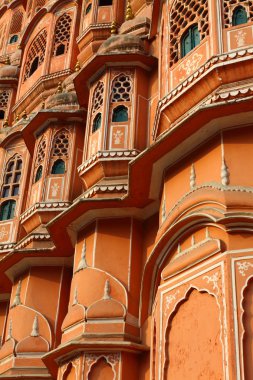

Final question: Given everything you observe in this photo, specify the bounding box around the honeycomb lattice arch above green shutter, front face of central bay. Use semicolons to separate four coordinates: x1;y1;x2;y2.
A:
111;74;132;103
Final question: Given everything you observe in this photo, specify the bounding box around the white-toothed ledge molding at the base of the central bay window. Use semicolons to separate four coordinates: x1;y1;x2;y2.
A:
77;149;140;174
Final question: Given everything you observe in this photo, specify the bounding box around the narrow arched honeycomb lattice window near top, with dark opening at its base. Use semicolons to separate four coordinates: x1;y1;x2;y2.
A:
53;13;72;56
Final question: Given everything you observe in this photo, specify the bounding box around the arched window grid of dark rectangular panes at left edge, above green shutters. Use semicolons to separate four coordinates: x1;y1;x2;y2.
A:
2;155;22;198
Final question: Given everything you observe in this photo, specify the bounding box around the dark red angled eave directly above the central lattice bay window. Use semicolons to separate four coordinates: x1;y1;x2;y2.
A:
74;52;157;106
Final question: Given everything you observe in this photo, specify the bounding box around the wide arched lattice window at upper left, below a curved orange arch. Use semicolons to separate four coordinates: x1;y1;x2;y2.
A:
24;29;47;80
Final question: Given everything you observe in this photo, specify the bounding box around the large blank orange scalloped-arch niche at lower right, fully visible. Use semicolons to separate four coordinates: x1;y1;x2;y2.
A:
163;288;223;380
